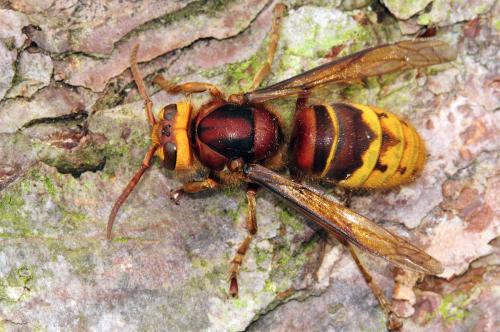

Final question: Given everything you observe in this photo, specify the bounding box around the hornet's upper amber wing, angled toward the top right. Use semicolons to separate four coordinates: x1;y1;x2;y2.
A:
244;39;456;103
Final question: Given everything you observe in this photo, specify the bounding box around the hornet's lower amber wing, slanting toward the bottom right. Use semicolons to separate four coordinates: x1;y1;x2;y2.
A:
245;165;443;274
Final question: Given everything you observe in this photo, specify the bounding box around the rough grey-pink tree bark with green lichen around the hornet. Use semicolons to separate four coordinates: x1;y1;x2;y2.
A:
0;0;500;331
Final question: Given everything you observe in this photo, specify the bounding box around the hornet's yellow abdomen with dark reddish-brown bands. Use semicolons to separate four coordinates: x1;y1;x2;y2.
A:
291;103;425;188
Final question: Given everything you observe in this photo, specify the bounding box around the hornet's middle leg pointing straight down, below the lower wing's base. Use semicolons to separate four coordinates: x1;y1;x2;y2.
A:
229;184;258;297
